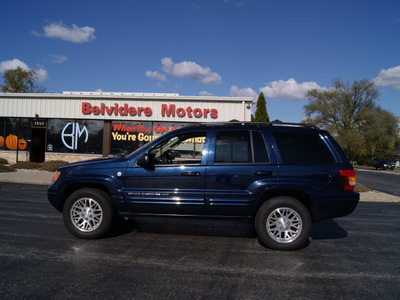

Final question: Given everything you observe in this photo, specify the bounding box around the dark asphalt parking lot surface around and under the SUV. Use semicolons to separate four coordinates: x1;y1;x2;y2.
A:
0;183;400;299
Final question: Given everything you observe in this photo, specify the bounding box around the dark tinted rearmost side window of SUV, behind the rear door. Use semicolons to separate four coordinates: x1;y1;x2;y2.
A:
273;132;335;164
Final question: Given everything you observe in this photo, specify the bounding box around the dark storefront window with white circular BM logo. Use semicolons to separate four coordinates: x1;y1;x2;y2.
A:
46;119;104;154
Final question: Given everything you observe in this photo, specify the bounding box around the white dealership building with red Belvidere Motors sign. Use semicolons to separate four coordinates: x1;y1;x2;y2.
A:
0;92;252;162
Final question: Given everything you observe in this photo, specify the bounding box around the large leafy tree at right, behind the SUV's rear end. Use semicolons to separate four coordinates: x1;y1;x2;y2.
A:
304;79;398;161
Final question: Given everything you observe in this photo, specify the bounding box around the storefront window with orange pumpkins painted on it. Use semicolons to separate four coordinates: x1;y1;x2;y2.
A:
0;118;31;151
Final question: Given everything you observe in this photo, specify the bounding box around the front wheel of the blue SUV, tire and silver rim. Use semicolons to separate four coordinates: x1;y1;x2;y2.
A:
63;188;114;239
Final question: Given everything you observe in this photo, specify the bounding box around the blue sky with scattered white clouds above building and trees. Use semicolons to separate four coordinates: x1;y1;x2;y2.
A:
0;0;400;122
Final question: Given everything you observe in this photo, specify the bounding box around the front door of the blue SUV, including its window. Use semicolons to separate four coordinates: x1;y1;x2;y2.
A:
124;130;209;215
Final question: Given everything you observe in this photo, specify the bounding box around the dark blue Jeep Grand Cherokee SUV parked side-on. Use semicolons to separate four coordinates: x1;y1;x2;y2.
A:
48;122;359;250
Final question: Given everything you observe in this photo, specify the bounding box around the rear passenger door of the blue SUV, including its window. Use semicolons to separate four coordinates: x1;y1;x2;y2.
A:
206;128;278;216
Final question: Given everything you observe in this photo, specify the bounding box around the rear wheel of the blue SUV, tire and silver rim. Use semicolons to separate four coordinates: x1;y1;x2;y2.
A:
255;196;312;251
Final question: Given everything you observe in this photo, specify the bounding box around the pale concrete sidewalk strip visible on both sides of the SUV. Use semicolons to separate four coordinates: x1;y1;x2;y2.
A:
0;170;400;203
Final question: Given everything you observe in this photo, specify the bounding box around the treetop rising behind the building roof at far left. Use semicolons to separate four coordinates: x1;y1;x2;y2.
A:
0;67;45;93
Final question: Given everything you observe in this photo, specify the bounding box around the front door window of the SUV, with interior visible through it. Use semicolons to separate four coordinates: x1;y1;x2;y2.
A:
149;132;207;165
